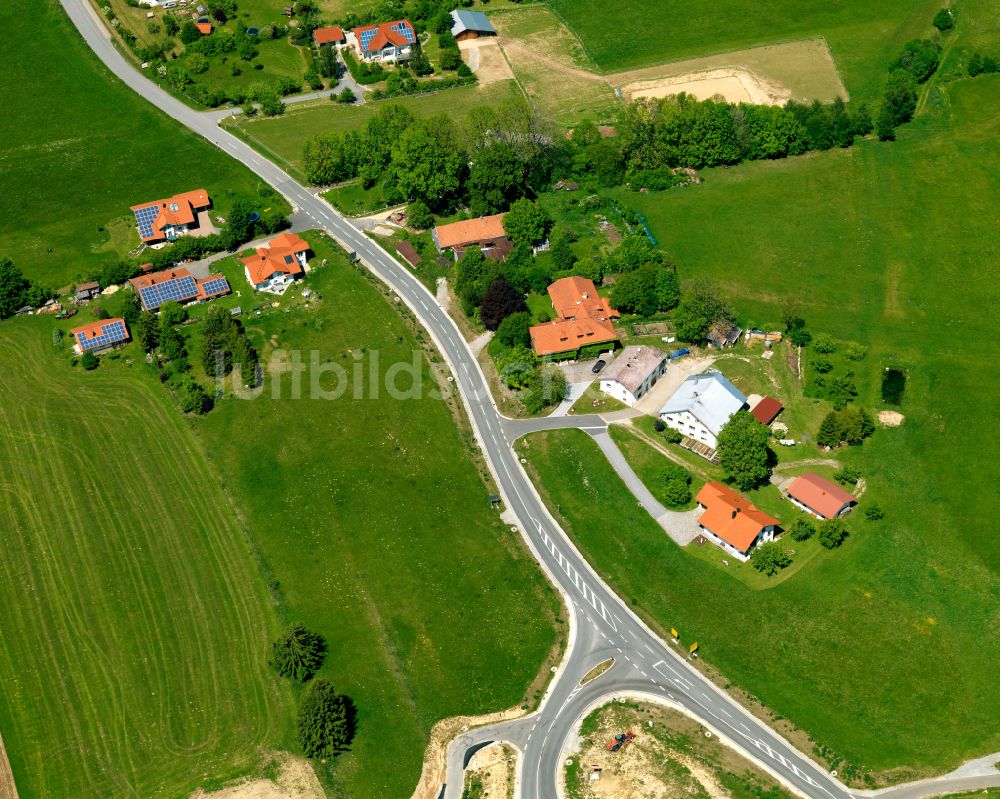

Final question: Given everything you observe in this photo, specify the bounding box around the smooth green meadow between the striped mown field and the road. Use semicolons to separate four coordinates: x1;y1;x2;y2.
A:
195;235;559;799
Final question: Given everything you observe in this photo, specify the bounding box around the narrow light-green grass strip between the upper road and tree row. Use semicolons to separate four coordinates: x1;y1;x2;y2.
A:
226;81;517;178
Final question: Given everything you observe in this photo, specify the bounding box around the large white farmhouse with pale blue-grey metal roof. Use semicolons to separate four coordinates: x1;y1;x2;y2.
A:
660;372;747;450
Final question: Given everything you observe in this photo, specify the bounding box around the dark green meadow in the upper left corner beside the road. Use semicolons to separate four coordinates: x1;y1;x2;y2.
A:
0;0;286;287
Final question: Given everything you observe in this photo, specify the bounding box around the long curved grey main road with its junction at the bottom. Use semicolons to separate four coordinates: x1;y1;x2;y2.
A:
61;0;1000;799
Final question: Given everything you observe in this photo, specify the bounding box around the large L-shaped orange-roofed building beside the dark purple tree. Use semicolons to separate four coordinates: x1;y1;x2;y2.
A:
529;277;619;358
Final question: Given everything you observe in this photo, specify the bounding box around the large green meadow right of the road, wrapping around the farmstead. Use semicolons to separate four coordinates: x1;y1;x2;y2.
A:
516;76;1000;770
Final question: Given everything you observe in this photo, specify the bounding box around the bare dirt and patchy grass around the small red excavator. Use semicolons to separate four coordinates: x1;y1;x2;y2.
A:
567;704;787;799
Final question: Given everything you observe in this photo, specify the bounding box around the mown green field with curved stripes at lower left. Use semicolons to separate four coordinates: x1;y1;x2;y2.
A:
0;318;292;799
